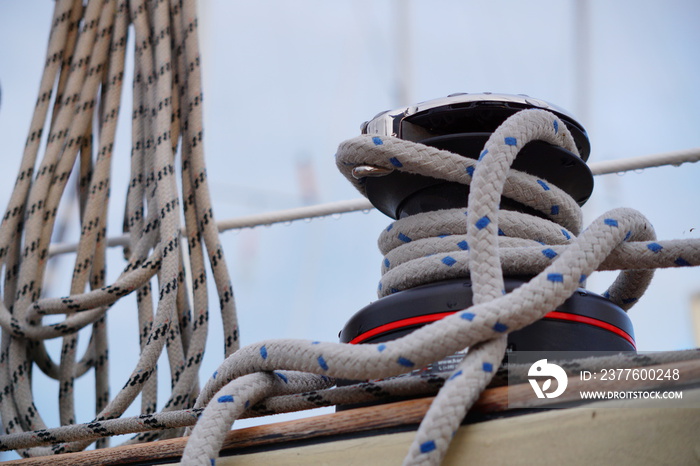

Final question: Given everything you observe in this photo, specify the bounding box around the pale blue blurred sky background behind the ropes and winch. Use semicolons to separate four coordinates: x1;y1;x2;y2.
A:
0;0;700;458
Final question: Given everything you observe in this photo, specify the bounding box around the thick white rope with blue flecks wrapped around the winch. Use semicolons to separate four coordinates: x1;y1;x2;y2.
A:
183;110;700;465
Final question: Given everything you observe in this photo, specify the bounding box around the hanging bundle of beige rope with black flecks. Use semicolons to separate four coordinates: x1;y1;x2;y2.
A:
0;0;238;456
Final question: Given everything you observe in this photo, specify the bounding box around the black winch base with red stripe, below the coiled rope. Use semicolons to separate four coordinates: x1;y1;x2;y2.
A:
340;277;635;352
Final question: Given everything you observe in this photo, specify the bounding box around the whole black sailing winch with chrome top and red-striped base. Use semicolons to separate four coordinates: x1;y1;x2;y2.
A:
340;93;636;382
